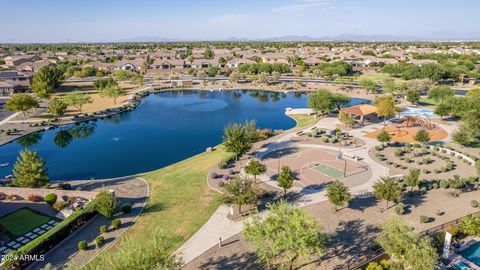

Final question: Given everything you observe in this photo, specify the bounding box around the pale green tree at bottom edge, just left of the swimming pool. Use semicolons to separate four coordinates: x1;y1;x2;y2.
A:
378;217;438;270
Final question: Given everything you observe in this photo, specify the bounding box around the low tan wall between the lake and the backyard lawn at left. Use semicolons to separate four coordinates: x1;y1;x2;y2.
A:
0;187;98;200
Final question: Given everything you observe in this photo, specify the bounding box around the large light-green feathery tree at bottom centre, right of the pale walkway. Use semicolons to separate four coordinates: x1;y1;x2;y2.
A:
243;200;327;269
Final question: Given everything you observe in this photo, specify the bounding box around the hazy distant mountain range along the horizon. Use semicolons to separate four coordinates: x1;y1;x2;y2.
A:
118;32;480;42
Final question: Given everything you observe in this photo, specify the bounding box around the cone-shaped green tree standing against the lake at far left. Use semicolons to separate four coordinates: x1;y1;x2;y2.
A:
13;149;48;188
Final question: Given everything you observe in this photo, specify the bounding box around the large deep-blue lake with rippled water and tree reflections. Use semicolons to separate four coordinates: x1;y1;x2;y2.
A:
0;90;368;180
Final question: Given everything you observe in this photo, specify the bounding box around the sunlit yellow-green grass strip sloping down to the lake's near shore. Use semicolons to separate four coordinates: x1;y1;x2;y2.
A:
86;146;228;269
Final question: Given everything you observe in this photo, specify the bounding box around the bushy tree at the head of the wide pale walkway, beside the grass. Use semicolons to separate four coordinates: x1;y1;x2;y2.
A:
221;176;259;213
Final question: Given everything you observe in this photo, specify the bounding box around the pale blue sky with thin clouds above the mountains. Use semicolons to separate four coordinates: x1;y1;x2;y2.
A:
0;0;480;42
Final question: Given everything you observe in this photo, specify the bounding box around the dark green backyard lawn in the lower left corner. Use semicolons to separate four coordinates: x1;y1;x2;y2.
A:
0;208;50;236
